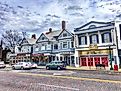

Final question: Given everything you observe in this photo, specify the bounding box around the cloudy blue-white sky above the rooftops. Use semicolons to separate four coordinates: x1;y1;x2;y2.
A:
0;0;121;35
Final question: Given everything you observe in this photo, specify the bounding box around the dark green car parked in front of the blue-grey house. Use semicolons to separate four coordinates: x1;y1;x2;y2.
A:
46;61;66;70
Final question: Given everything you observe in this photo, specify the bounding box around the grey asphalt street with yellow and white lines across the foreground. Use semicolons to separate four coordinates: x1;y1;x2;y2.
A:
0;69;121;91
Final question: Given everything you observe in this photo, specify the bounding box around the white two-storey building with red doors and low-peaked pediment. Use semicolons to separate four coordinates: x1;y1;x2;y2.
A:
74;21;119;68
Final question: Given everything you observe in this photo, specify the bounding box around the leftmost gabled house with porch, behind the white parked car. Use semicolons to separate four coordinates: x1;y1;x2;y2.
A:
10;35;36;64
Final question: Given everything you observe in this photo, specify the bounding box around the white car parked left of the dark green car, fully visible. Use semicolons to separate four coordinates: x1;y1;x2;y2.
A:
12;62;31;70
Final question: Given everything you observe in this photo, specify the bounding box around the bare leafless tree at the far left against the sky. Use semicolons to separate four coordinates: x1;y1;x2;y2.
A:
2;30;23;49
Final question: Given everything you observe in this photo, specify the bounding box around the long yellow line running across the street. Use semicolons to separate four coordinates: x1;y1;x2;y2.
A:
18;73;121;84
